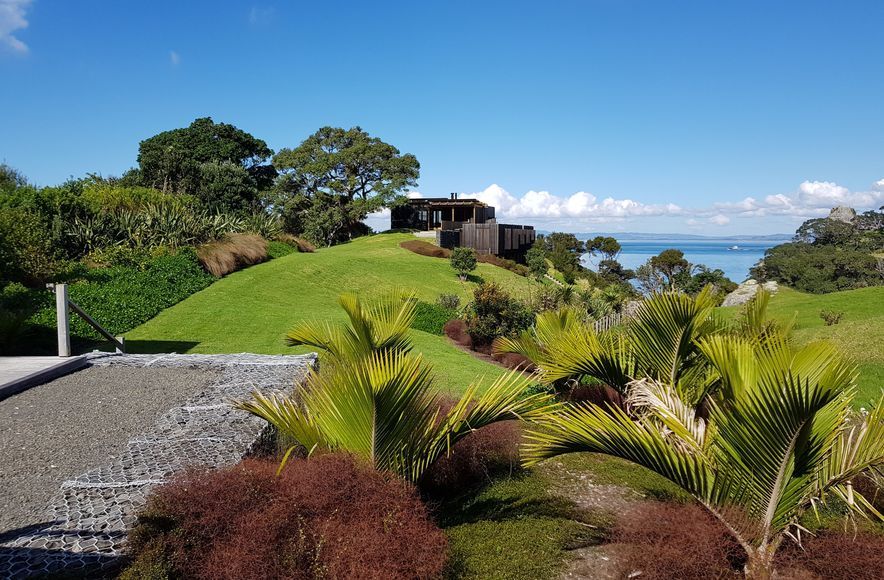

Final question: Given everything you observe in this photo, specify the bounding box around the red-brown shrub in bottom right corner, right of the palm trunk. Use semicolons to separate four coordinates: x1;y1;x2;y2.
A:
776;532;884;580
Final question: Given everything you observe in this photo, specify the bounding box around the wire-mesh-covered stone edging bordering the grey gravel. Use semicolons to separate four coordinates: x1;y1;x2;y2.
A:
0;353;317;578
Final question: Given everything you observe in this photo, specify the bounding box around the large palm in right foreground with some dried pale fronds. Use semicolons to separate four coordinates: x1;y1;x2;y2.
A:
525;294;884;578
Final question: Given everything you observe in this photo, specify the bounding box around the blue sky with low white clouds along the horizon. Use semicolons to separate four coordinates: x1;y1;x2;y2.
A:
0;0;884;234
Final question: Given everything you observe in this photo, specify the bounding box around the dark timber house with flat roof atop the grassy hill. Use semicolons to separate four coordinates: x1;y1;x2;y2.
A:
390;193;535;262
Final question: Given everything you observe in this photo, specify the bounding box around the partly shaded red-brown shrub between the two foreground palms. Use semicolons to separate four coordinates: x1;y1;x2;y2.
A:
420;416;522;499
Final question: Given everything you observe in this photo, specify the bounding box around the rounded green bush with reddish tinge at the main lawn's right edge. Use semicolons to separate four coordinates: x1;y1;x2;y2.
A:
467;282;534;347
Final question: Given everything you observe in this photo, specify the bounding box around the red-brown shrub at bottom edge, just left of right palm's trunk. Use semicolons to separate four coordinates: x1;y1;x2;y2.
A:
613;502;744;580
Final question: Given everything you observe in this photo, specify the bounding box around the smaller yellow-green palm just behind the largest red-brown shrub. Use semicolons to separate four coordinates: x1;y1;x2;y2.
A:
236;293;556;482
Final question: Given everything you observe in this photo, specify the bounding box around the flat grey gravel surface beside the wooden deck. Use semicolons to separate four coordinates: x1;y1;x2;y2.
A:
0;366;219;533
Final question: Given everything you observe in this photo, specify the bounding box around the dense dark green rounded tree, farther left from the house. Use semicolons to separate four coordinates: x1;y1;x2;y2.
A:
137;117;275;209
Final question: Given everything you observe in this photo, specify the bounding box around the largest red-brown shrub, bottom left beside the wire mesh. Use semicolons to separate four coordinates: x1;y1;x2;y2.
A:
124;455;447;579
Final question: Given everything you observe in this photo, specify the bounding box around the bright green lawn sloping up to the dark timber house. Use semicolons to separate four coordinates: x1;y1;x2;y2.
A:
126;234;532;393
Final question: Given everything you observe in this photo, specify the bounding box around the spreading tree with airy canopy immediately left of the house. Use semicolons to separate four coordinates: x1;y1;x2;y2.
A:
273;127;420;245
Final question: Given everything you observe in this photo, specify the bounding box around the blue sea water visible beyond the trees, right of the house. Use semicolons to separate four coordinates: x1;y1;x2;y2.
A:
583;239;782;283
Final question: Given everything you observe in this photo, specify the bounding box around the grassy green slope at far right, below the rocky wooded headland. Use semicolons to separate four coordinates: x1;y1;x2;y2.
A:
727;286;884;407
